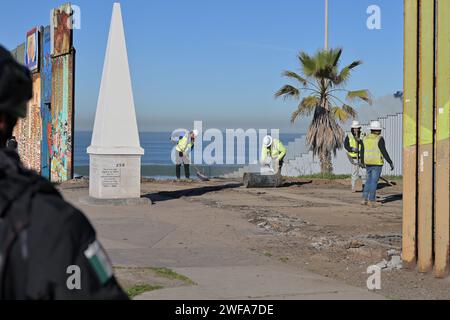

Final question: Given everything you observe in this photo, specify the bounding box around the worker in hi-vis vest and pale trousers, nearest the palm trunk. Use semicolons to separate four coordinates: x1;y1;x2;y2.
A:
344;121;366;192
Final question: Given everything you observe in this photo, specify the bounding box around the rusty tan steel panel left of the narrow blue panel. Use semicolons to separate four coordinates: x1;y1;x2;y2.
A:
14;73;41;173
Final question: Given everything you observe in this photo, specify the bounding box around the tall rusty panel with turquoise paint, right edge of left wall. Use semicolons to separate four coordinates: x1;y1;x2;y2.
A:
50;52;75;182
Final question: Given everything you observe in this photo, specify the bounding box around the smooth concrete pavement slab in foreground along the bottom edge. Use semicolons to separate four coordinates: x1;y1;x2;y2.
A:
138;265;384;300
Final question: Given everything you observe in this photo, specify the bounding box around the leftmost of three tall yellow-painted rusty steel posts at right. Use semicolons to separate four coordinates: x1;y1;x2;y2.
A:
402;0;418;267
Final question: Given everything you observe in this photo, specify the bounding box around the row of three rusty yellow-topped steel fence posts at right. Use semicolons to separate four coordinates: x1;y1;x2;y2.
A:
403;0;450;278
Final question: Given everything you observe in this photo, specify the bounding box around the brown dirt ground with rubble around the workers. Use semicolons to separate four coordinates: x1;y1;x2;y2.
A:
137;179;450;299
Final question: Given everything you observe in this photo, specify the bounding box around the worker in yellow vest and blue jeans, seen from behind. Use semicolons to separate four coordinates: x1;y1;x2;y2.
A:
360;121;394;207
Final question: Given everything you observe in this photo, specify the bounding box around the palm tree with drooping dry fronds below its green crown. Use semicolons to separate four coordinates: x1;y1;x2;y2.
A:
275;49;372;173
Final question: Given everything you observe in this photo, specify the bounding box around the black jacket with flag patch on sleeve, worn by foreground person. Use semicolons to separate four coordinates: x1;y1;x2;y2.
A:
0;150;127;300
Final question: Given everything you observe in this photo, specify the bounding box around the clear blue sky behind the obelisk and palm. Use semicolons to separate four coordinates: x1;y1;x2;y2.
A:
0;0;403;132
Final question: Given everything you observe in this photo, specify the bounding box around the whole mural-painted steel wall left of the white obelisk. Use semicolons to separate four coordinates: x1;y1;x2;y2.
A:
12;4;75;182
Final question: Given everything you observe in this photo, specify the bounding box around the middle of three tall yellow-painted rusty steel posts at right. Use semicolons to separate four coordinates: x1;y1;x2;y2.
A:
417;0;435;272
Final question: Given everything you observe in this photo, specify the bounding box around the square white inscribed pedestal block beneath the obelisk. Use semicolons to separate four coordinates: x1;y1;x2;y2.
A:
89;154;141;200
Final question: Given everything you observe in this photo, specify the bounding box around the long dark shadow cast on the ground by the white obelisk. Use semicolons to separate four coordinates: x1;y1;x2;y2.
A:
144;183;242;203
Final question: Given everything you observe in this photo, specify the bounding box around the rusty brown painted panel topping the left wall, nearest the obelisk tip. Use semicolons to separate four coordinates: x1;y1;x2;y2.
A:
51;4;72;57
